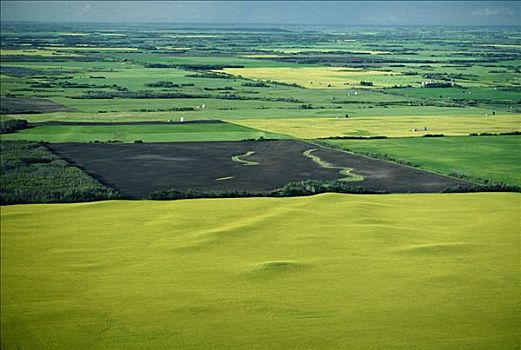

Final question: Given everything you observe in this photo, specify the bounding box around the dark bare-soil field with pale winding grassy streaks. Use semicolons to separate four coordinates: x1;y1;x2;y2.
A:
48;141;464;198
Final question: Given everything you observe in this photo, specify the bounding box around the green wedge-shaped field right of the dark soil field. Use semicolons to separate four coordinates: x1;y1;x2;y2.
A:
320;136;521;185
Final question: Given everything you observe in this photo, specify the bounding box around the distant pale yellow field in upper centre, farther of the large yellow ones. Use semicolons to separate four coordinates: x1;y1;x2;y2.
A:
220;67;399;89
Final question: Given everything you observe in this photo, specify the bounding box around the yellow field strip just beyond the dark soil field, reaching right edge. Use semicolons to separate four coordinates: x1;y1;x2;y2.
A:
233;114;521;139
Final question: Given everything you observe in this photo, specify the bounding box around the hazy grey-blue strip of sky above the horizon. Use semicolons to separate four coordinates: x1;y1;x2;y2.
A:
0;0;521;25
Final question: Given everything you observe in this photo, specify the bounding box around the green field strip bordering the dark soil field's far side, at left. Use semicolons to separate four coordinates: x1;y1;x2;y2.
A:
2;123;287;142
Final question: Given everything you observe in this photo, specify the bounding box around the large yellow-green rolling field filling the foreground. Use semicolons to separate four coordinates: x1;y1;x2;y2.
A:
1;193;521;350
